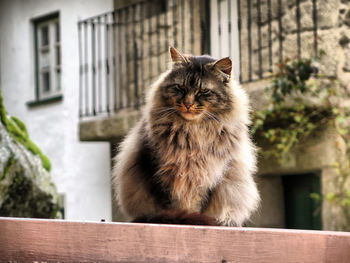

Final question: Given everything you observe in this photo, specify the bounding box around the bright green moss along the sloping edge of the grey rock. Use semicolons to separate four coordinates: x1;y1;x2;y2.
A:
0;90;51;171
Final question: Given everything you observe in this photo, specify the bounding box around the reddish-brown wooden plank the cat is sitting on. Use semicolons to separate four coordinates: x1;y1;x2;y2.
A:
0;218;350;263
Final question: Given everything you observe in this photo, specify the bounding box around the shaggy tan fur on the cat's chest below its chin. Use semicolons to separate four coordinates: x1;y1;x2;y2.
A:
151;120;234;211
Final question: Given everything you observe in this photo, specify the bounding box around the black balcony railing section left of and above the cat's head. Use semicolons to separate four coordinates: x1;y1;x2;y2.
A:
78;0;209;117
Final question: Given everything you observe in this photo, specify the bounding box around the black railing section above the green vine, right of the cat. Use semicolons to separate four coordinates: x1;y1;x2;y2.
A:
237;0;318;83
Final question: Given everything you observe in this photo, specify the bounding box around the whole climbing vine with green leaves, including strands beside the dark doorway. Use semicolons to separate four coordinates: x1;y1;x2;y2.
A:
252;58;350;230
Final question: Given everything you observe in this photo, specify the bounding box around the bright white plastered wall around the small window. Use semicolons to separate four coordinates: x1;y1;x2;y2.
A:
0;0;113;223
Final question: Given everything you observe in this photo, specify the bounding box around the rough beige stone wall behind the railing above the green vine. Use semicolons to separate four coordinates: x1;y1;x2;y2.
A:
241;0;350;81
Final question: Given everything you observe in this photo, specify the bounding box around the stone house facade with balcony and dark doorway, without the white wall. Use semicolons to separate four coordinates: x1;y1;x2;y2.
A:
80;0;350;230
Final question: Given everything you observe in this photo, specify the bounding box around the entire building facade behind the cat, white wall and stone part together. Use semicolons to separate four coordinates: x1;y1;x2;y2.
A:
0;0;350;230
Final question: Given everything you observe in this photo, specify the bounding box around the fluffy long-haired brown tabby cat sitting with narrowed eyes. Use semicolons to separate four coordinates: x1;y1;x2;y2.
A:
113;47;259;226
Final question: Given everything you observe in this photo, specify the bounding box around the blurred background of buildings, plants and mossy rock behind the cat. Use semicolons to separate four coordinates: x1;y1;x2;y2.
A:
0;0;350;230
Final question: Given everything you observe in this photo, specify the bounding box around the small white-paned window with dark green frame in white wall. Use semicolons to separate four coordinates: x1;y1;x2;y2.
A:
28;13;62;105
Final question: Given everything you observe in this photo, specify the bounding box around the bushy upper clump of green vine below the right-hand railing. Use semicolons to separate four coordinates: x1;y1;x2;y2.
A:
252;59;347;162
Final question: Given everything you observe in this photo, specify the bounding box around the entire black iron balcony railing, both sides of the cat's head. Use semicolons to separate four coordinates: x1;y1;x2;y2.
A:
78;0;318;117
